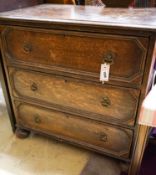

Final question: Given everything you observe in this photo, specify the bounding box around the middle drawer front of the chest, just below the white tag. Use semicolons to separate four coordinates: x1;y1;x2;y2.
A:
10;69;139;125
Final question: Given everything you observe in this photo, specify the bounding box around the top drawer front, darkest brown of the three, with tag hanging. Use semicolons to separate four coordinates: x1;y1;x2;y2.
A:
3;28;148;86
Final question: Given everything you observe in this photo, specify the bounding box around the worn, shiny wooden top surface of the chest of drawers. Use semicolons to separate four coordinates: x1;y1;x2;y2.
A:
0;4;156;31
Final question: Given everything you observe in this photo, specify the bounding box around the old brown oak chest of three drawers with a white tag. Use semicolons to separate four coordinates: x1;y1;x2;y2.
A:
0;5;156;175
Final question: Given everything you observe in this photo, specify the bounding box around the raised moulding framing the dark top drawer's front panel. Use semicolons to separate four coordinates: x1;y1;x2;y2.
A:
2;26;149;86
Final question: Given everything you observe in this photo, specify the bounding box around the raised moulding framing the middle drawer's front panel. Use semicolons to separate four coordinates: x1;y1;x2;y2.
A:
8;67;140;128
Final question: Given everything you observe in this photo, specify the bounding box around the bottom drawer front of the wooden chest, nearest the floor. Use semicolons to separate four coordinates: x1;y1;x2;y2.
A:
16;103;132;158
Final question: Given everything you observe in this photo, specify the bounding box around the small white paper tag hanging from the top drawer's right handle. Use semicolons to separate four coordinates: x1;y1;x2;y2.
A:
100;63;110;82
